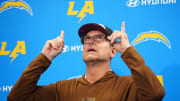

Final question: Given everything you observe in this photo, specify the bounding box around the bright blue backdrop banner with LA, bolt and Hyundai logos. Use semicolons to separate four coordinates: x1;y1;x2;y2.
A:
0;0;180;101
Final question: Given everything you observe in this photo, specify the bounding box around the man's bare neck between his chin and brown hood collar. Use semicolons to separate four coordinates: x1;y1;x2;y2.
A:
85;62;111;84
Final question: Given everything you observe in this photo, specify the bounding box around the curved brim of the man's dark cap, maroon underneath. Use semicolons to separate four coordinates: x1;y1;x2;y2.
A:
78;23;108;38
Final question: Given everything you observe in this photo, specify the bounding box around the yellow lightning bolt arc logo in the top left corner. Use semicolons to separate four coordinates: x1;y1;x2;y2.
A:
0;0;33;16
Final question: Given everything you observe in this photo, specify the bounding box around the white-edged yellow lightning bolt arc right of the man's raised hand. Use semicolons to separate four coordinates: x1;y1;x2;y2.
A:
131;31;171;49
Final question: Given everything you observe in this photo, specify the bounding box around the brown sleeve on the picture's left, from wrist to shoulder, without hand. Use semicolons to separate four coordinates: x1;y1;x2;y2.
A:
7;53;56;101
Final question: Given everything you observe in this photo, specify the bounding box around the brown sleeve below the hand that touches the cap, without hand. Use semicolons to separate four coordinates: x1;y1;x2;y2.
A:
121;46;165;101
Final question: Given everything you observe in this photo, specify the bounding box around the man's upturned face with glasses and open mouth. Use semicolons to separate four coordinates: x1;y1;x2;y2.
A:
83;31;114;62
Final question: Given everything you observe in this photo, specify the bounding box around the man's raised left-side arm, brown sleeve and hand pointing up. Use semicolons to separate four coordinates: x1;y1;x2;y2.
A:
8;31;64;101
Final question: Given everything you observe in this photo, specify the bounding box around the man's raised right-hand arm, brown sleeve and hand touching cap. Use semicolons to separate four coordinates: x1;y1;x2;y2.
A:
108;22;165;101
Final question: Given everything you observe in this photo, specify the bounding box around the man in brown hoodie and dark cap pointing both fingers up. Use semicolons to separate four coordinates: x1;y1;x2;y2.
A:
8;22;165;101
